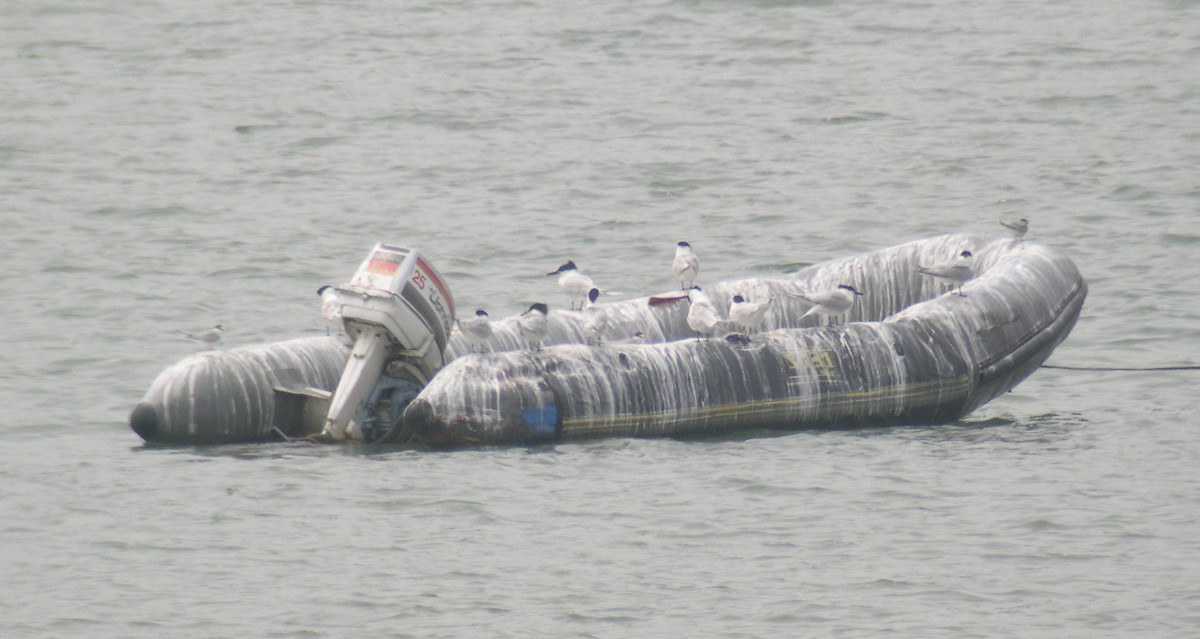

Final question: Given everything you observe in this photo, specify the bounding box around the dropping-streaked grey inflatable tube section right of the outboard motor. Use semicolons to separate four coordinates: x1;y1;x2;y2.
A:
392;234;1087;447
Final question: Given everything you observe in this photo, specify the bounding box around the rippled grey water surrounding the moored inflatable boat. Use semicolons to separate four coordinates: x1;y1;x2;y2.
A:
0;0;1200;639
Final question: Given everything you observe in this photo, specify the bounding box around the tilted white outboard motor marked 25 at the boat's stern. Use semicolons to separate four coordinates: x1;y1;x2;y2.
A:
322;244;455;441
